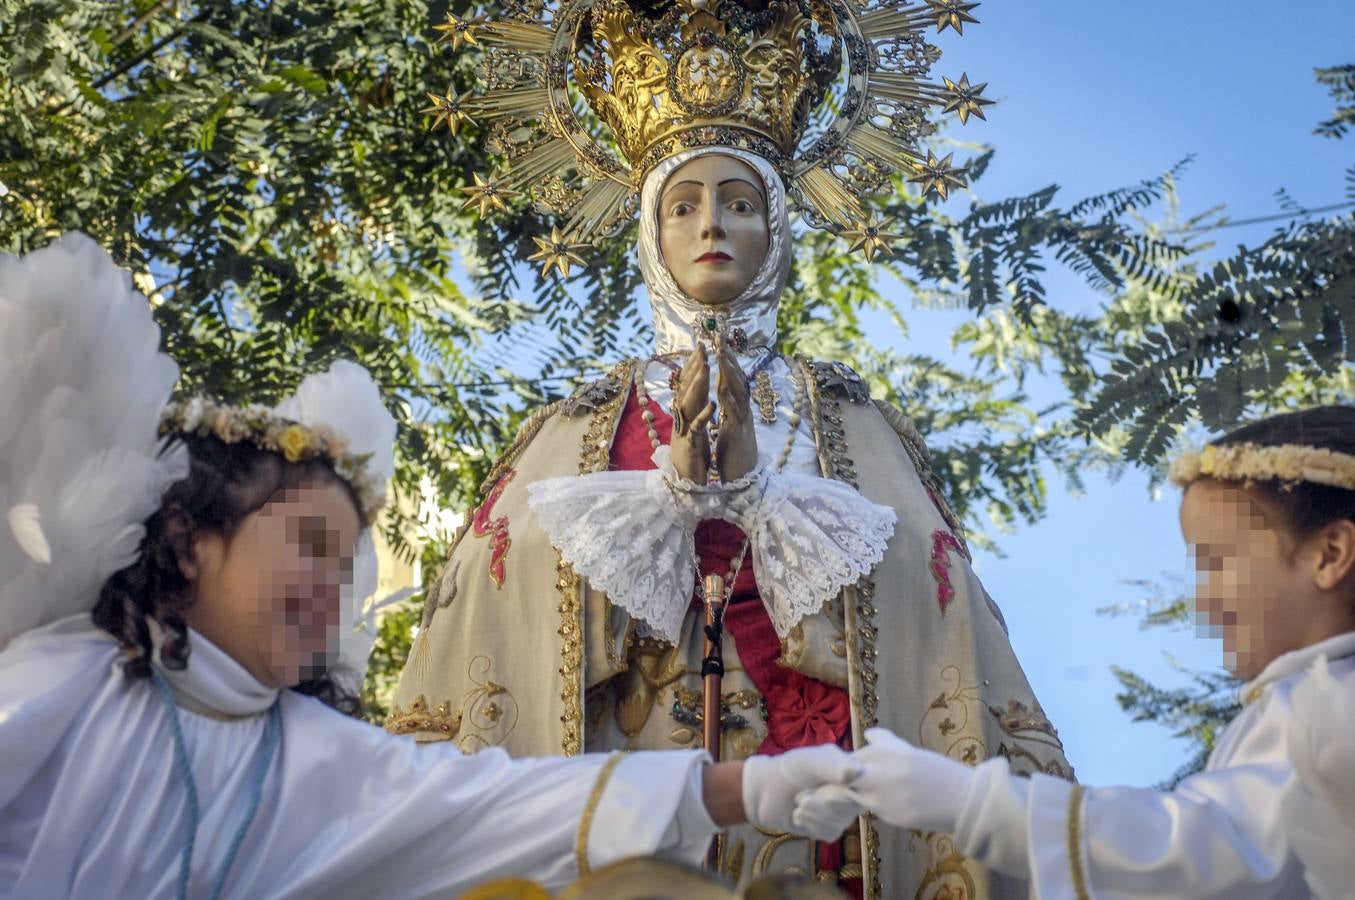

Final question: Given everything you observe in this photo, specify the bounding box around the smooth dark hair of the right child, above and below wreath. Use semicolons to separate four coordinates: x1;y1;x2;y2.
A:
1213;407;1355;539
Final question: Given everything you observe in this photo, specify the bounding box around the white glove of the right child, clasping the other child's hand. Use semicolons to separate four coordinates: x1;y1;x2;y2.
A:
793;728;974;834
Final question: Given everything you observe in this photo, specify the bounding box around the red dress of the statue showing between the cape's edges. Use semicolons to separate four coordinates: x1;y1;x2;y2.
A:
610;390;862;897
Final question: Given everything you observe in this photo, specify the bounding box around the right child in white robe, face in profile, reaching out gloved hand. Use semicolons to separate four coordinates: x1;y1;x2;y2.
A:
795;407;1355;900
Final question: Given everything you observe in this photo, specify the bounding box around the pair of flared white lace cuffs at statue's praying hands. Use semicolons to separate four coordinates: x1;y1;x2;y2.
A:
527;447;897;642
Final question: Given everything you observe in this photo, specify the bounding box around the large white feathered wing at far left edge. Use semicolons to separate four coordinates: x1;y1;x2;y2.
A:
0;234;188;649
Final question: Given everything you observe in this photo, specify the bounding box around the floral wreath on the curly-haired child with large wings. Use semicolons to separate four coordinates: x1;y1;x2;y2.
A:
160;397;386;527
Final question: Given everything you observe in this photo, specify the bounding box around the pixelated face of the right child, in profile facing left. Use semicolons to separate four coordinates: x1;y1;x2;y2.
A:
1180;481;1317;679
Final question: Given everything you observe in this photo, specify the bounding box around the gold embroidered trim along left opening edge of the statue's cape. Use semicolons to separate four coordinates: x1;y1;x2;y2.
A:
556;359;635;756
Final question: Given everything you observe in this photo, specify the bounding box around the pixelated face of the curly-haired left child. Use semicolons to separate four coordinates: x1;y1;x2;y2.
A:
186;481;360;687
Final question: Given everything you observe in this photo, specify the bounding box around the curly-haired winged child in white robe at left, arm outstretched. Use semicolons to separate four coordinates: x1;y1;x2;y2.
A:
0;236;859;899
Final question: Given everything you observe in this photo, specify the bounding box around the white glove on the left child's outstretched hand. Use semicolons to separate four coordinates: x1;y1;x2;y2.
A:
743;744;862;840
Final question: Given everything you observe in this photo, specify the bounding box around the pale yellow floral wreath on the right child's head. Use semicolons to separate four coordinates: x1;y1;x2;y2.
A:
1169;443;1355;491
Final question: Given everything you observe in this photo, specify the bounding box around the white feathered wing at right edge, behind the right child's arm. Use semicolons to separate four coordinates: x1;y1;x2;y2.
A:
1283;657;1355;900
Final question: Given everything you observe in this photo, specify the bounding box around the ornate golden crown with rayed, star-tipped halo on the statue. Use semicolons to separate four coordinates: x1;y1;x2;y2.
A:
425;0;989;277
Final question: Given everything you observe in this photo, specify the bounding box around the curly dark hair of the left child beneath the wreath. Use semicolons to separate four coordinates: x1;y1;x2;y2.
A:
93;435;362;716
